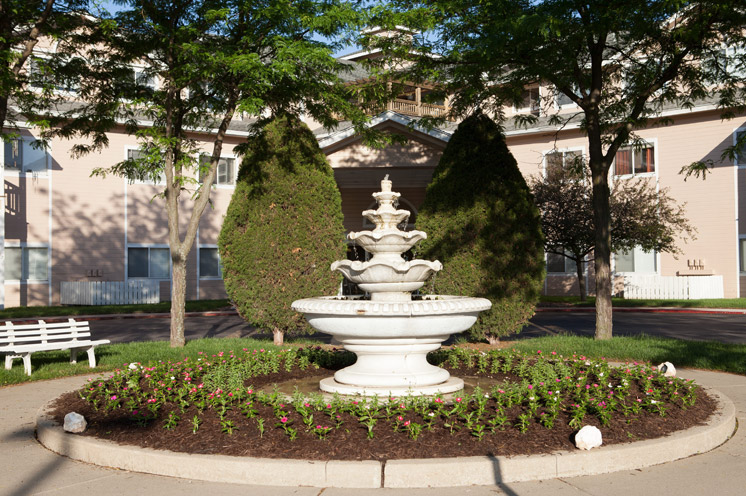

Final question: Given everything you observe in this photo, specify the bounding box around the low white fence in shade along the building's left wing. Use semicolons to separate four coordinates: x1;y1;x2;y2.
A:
60;280;161;305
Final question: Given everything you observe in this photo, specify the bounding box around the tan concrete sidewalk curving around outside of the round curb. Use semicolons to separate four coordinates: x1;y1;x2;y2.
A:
0;370;746;496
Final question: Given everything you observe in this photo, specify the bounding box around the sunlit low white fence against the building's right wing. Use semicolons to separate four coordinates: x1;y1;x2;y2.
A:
624;275;723;300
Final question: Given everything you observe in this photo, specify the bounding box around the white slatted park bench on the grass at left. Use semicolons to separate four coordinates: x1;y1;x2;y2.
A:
0;319;109;375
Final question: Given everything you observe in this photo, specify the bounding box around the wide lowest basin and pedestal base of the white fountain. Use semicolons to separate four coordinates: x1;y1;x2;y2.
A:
293;295;491;396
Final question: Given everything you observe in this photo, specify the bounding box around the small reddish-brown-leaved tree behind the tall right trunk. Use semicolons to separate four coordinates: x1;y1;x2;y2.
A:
529;168;694;301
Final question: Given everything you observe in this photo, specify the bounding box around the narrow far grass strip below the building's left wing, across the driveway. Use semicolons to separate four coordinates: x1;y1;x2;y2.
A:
0;300;231;320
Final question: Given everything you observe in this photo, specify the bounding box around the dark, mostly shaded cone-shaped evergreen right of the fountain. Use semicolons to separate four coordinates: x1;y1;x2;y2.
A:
417;113;544;344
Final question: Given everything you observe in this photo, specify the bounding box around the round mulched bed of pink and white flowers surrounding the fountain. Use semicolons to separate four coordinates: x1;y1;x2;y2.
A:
53;347;713;459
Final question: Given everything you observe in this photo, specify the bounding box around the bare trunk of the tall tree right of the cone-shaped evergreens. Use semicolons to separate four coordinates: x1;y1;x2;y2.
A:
593;171;612;339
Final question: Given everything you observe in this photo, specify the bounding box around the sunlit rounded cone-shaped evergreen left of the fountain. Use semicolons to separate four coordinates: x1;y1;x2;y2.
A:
219;114;346;345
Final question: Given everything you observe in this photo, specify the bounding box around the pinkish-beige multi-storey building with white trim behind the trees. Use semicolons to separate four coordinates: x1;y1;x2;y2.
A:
0;45;746;306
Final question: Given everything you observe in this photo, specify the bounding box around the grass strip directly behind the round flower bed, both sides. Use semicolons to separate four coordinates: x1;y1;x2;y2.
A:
0;336;746;386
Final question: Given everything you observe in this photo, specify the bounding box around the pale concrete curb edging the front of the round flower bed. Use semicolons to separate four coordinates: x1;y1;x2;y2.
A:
36;389;736;488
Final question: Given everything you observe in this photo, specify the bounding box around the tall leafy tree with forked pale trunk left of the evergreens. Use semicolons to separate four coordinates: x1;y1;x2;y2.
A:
61;0;362;346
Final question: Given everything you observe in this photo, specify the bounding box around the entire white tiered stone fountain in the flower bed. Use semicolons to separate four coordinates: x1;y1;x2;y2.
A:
293;175;492;396
